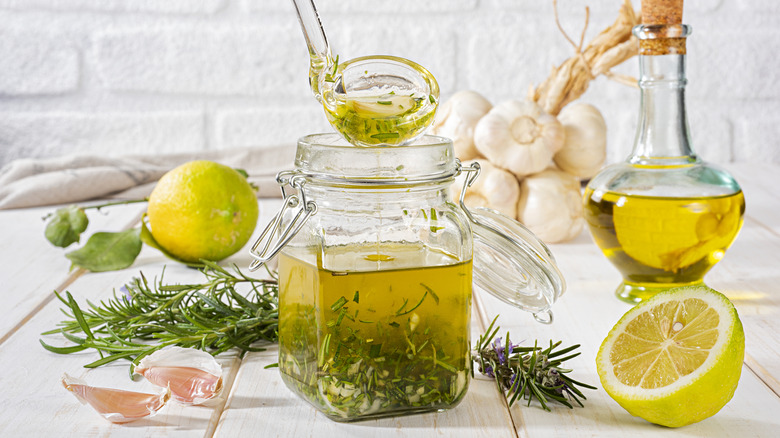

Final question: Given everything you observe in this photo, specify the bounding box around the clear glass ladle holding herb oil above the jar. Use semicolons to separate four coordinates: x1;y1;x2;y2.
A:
292;0;439;146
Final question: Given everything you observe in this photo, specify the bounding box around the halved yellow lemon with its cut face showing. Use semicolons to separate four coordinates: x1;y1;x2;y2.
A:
596;286;745;427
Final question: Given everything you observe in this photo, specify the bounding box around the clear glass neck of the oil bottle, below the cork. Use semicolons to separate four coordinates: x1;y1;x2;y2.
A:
628;54;699;167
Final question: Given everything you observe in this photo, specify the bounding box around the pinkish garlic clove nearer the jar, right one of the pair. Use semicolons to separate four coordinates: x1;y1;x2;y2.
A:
135;347;222;405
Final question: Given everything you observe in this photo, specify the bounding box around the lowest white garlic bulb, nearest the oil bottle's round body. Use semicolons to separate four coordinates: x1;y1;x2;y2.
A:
517;168;585;243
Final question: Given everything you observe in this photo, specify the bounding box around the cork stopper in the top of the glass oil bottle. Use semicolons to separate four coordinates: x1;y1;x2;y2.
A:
639;0;685;55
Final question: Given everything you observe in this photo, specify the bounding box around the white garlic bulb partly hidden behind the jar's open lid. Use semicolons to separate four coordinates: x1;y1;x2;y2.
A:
453;159;520;218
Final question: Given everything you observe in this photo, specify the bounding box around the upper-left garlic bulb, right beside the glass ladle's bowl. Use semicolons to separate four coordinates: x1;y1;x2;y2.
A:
431;91;493;160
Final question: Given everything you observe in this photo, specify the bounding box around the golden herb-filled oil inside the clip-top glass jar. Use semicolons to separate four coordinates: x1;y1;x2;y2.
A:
279;244;472;421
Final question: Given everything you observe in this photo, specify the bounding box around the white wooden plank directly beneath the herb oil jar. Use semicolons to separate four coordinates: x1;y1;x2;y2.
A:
214;296;516;438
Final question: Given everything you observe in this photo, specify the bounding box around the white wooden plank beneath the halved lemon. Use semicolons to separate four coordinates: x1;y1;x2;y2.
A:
482;226;780;437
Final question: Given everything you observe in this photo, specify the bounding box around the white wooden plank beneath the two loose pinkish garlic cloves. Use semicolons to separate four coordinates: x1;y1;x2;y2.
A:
0;200;286;437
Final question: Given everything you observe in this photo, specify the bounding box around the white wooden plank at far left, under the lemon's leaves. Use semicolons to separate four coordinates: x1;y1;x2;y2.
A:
0;204;145;345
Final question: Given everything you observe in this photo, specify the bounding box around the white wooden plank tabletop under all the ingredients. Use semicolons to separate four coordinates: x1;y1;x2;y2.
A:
0;165;780;438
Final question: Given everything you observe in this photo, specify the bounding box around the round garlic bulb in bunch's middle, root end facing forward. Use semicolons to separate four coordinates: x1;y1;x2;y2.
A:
474;100;566;178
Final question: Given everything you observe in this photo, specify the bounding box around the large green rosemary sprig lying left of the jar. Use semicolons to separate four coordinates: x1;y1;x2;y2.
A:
40;261;278;371
